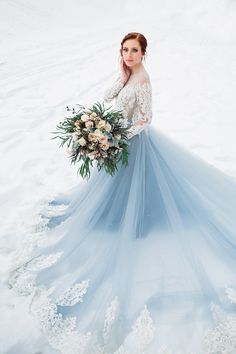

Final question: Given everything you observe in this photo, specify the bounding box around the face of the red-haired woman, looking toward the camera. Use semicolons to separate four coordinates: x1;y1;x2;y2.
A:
122;39;143;67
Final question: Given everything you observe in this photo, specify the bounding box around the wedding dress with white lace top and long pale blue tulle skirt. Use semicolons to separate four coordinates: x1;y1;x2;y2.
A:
9;71;236;354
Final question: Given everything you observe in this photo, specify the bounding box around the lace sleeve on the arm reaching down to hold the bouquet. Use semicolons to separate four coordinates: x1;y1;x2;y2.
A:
128;80;152;139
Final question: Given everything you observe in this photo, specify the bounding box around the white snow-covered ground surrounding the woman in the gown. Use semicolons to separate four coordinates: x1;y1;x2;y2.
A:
0;0;236;354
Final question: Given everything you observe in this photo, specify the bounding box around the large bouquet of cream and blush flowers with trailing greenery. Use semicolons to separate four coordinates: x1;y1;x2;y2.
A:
52;102;129;178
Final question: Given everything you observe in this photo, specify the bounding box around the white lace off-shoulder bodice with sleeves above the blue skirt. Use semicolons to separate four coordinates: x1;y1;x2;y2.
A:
103;71;152;137
